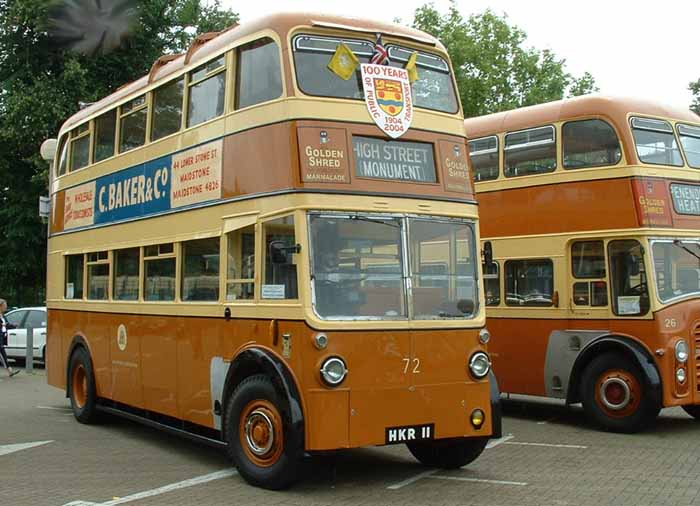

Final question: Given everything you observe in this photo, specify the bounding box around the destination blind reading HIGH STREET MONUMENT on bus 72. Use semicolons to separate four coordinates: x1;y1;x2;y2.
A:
352;136;437;183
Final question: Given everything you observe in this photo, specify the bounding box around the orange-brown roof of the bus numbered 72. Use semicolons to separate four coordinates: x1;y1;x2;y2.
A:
61;12;446;131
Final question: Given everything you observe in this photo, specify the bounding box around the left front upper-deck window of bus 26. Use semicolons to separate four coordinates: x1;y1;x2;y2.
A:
632;118;683;167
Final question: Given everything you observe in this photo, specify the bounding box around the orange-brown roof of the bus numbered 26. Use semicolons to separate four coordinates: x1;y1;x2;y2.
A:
464;95;700;139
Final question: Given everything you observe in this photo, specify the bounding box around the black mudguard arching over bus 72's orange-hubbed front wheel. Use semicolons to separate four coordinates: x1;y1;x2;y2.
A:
223;348;304;448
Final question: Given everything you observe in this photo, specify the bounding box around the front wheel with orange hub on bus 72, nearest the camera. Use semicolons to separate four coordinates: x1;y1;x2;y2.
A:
224;374;304;490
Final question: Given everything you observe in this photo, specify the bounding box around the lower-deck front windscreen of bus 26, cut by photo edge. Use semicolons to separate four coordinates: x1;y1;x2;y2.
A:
652;239;700;302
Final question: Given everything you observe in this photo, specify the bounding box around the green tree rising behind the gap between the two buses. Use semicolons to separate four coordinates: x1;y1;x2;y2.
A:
413;2;597;117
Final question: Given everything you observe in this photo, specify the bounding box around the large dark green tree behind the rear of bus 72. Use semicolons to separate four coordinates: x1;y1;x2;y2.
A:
0;0;238;305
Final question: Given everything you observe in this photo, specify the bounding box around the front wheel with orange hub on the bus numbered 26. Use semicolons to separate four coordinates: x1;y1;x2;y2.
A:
581;353;661;433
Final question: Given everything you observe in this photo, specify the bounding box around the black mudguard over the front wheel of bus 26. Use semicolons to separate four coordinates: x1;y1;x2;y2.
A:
566;335;663;406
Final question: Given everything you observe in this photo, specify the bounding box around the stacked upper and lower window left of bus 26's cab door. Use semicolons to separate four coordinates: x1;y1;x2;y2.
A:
571;241;608;307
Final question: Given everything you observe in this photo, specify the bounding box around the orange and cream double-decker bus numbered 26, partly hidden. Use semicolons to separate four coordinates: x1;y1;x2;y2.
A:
465;96;700;431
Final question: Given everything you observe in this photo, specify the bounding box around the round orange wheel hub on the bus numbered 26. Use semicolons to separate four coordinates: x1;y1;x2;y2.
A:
595;369;642;418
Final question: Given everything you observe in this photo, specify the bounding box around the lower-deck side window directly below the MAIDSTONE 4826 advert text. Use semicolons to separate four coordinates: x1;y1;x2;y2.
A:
182;237;220;301
